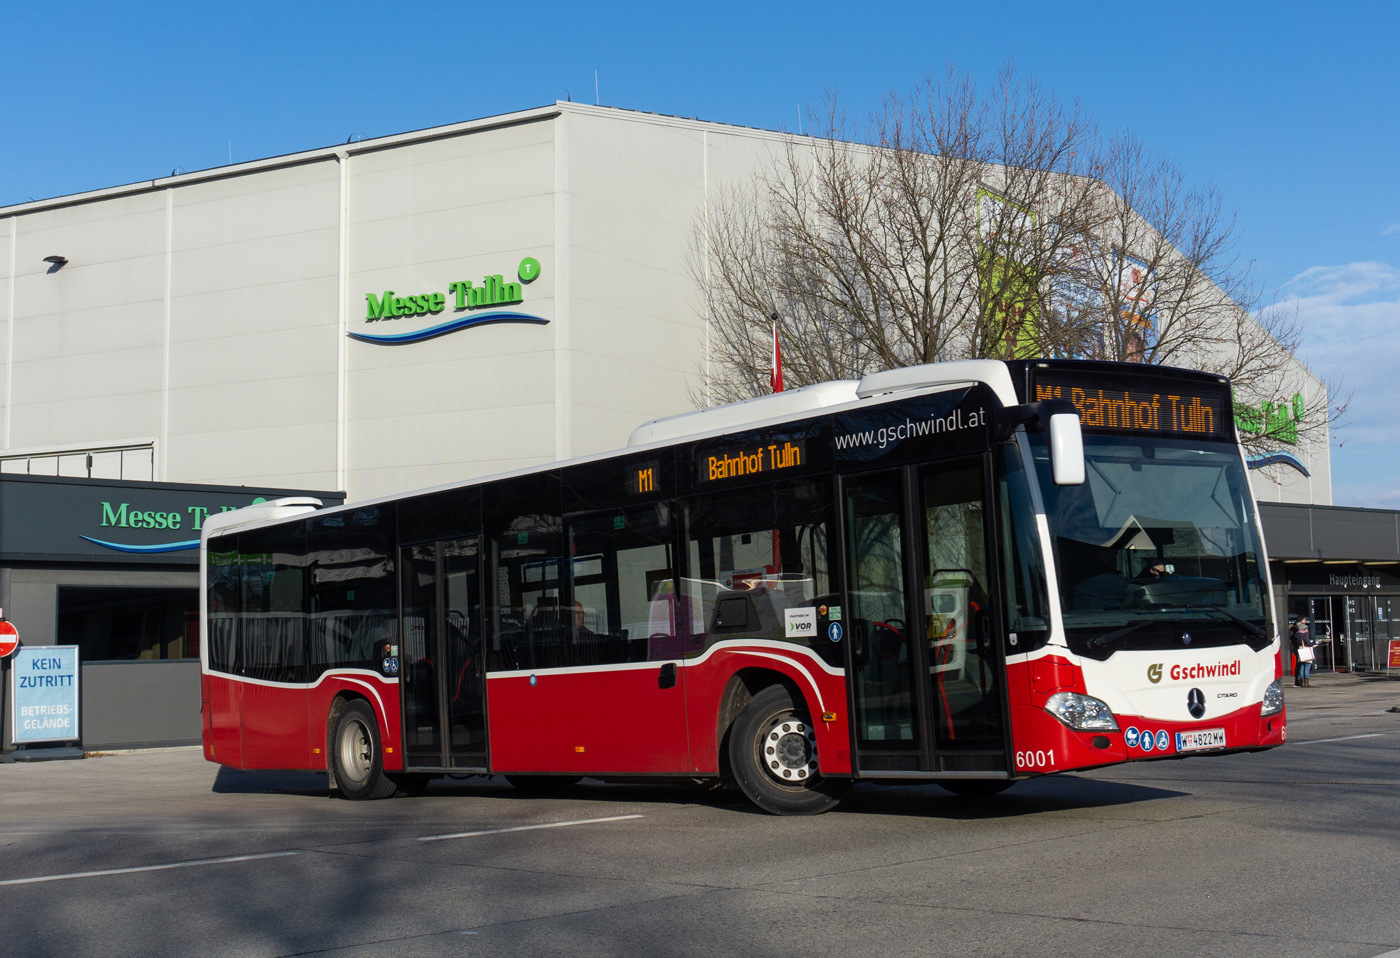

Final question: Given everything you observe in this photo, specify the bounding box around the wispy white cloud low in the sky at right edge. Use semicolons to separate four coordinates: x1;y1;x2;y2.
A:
1284;262;1400;508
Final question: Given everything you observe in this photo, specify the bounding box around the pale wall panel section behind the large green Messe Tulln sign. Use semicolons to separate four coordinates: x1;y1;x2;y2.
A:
347;122;559;499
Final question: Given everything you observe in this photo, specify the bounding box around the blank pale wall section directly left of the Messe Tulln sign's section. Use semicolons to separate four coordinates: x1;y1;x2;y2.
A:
167;160;340;489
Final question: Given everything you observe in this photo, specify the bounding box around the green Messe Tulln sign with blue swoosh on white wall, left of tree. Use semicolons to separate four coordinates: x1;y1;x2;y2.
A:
346;256;549;346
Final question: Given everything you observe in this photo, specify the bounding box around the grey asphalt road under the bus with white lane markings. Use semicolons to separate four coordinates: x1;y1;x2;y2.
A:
0;676;1400;958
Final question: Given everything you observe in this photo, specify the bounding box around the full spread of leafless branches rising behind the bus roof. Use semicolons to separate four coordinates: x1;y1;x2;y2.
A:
690;67;1337;459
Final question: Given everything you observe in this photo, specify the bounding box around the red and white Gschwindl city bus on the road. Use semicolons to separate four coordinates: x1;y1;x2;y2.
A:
200;360;1285;814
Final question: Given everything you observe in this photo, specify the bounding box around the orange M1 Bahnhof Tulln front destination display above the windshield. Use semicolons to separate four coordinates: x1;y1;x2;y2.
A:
1035;375;1229;438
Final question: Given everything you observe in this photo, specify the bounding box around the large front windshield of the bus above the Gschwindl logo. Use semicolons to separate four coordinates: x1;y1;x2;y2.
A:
1029;434;1268;658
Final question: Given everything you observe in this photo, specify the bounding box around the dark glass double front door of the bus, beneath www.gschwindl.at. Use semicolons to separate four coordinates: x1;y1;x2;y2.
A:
841;457;1007;776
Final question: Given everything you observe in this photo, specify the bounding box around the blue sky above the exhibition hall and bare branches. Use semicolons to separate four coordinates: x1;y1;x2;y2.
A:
0;0;1400;508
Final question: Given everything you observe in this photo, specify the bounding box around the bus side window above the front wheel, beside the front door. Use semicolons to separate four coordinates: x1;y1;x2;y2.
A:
679;479;841;664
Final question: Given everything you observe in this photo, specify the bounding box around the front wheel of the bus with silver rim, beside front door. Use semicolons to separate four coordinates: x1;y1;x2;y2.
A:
729;685;851;815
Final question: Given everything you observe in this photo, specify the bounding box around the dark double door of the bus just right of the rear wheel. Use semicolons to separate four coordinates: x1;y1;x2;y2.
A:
399;538;486;770
